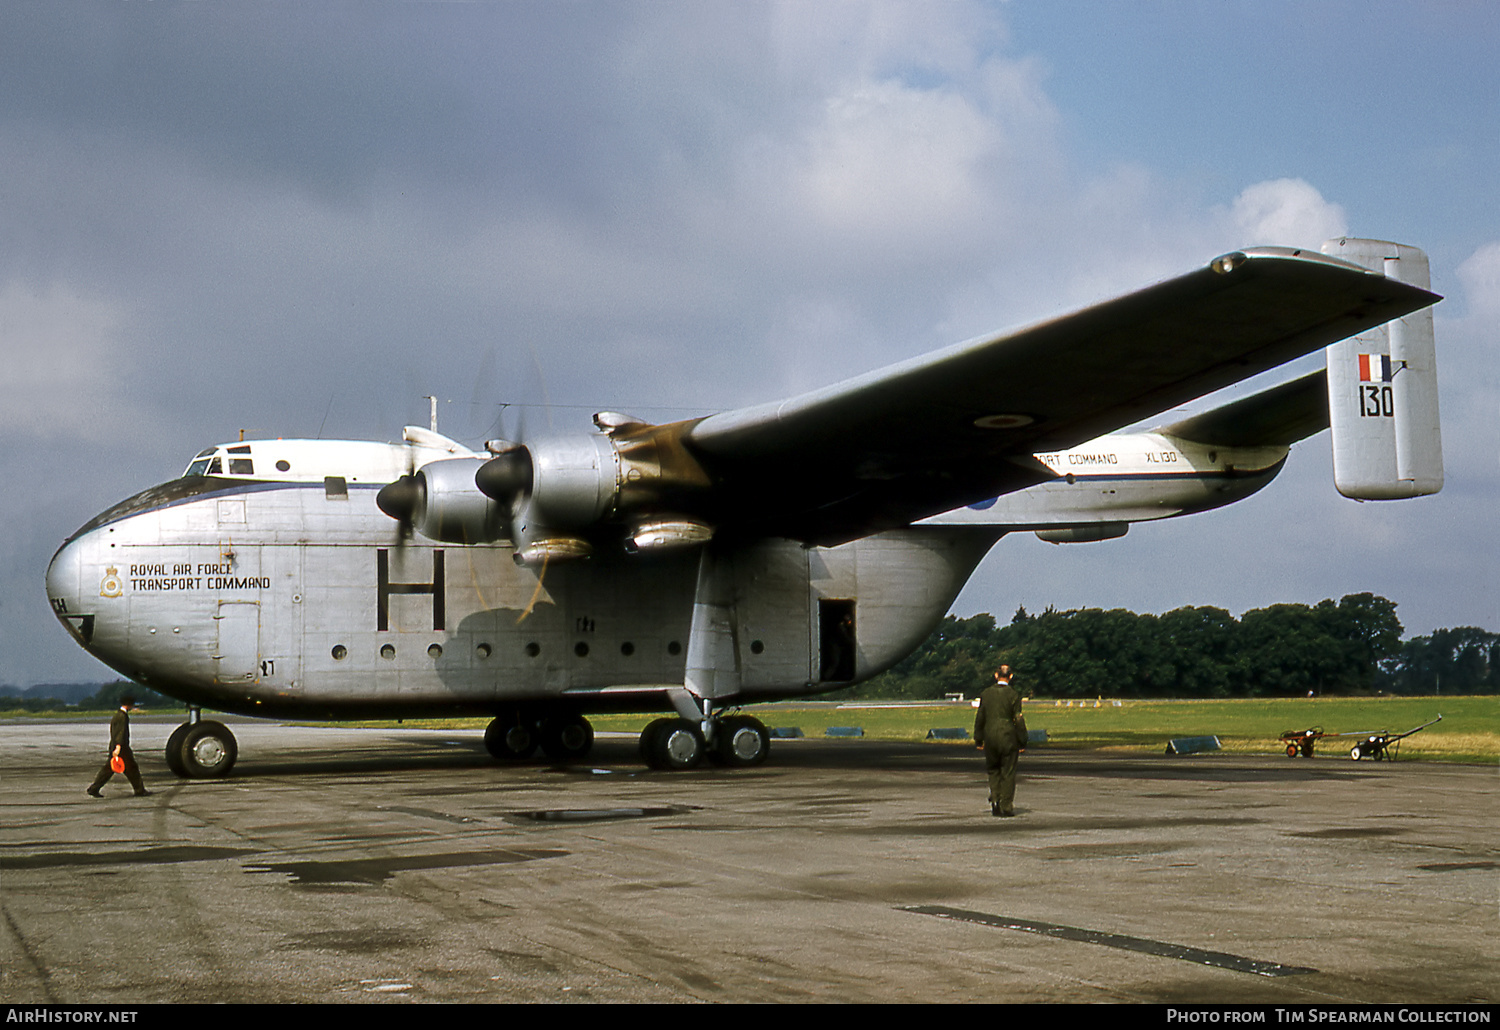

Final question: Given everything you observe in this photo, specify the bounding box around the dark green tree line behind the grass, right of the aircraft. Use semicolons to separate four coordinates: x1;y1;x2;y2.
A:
840;594;1500;699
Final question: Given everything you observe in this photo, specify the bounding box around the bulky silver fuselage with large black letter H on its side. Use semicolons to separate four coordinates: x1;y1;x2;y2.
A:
47;435;1286;718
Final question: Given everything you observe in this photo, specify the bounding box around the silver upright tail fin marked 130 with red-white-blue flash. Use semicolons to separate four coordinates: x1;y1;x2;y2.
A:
1323;237;1443;501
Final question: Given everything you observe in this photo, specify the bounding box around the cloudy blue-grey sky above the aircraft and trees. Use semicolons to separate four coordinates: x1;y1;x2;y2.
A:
0;0;1500;684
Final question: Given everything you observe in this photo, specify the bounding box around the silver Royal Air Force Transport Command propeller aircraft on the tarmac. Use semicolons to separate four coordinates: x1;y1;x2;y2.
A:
47;240;1442;777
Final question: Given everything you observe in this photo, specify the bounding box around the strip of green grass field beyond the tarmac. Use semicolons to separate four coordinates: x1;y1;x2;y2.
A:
0;697;1500;763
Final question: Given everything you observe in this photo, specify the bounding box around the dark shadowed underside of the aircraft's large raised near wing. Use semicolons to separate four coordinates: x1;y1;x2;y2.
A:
684;247;1439;544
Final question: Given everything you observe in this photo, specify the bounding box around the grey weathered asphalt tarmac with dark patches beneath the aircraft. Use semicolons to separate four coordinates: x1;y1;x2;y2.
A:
0;717;1500;1005
